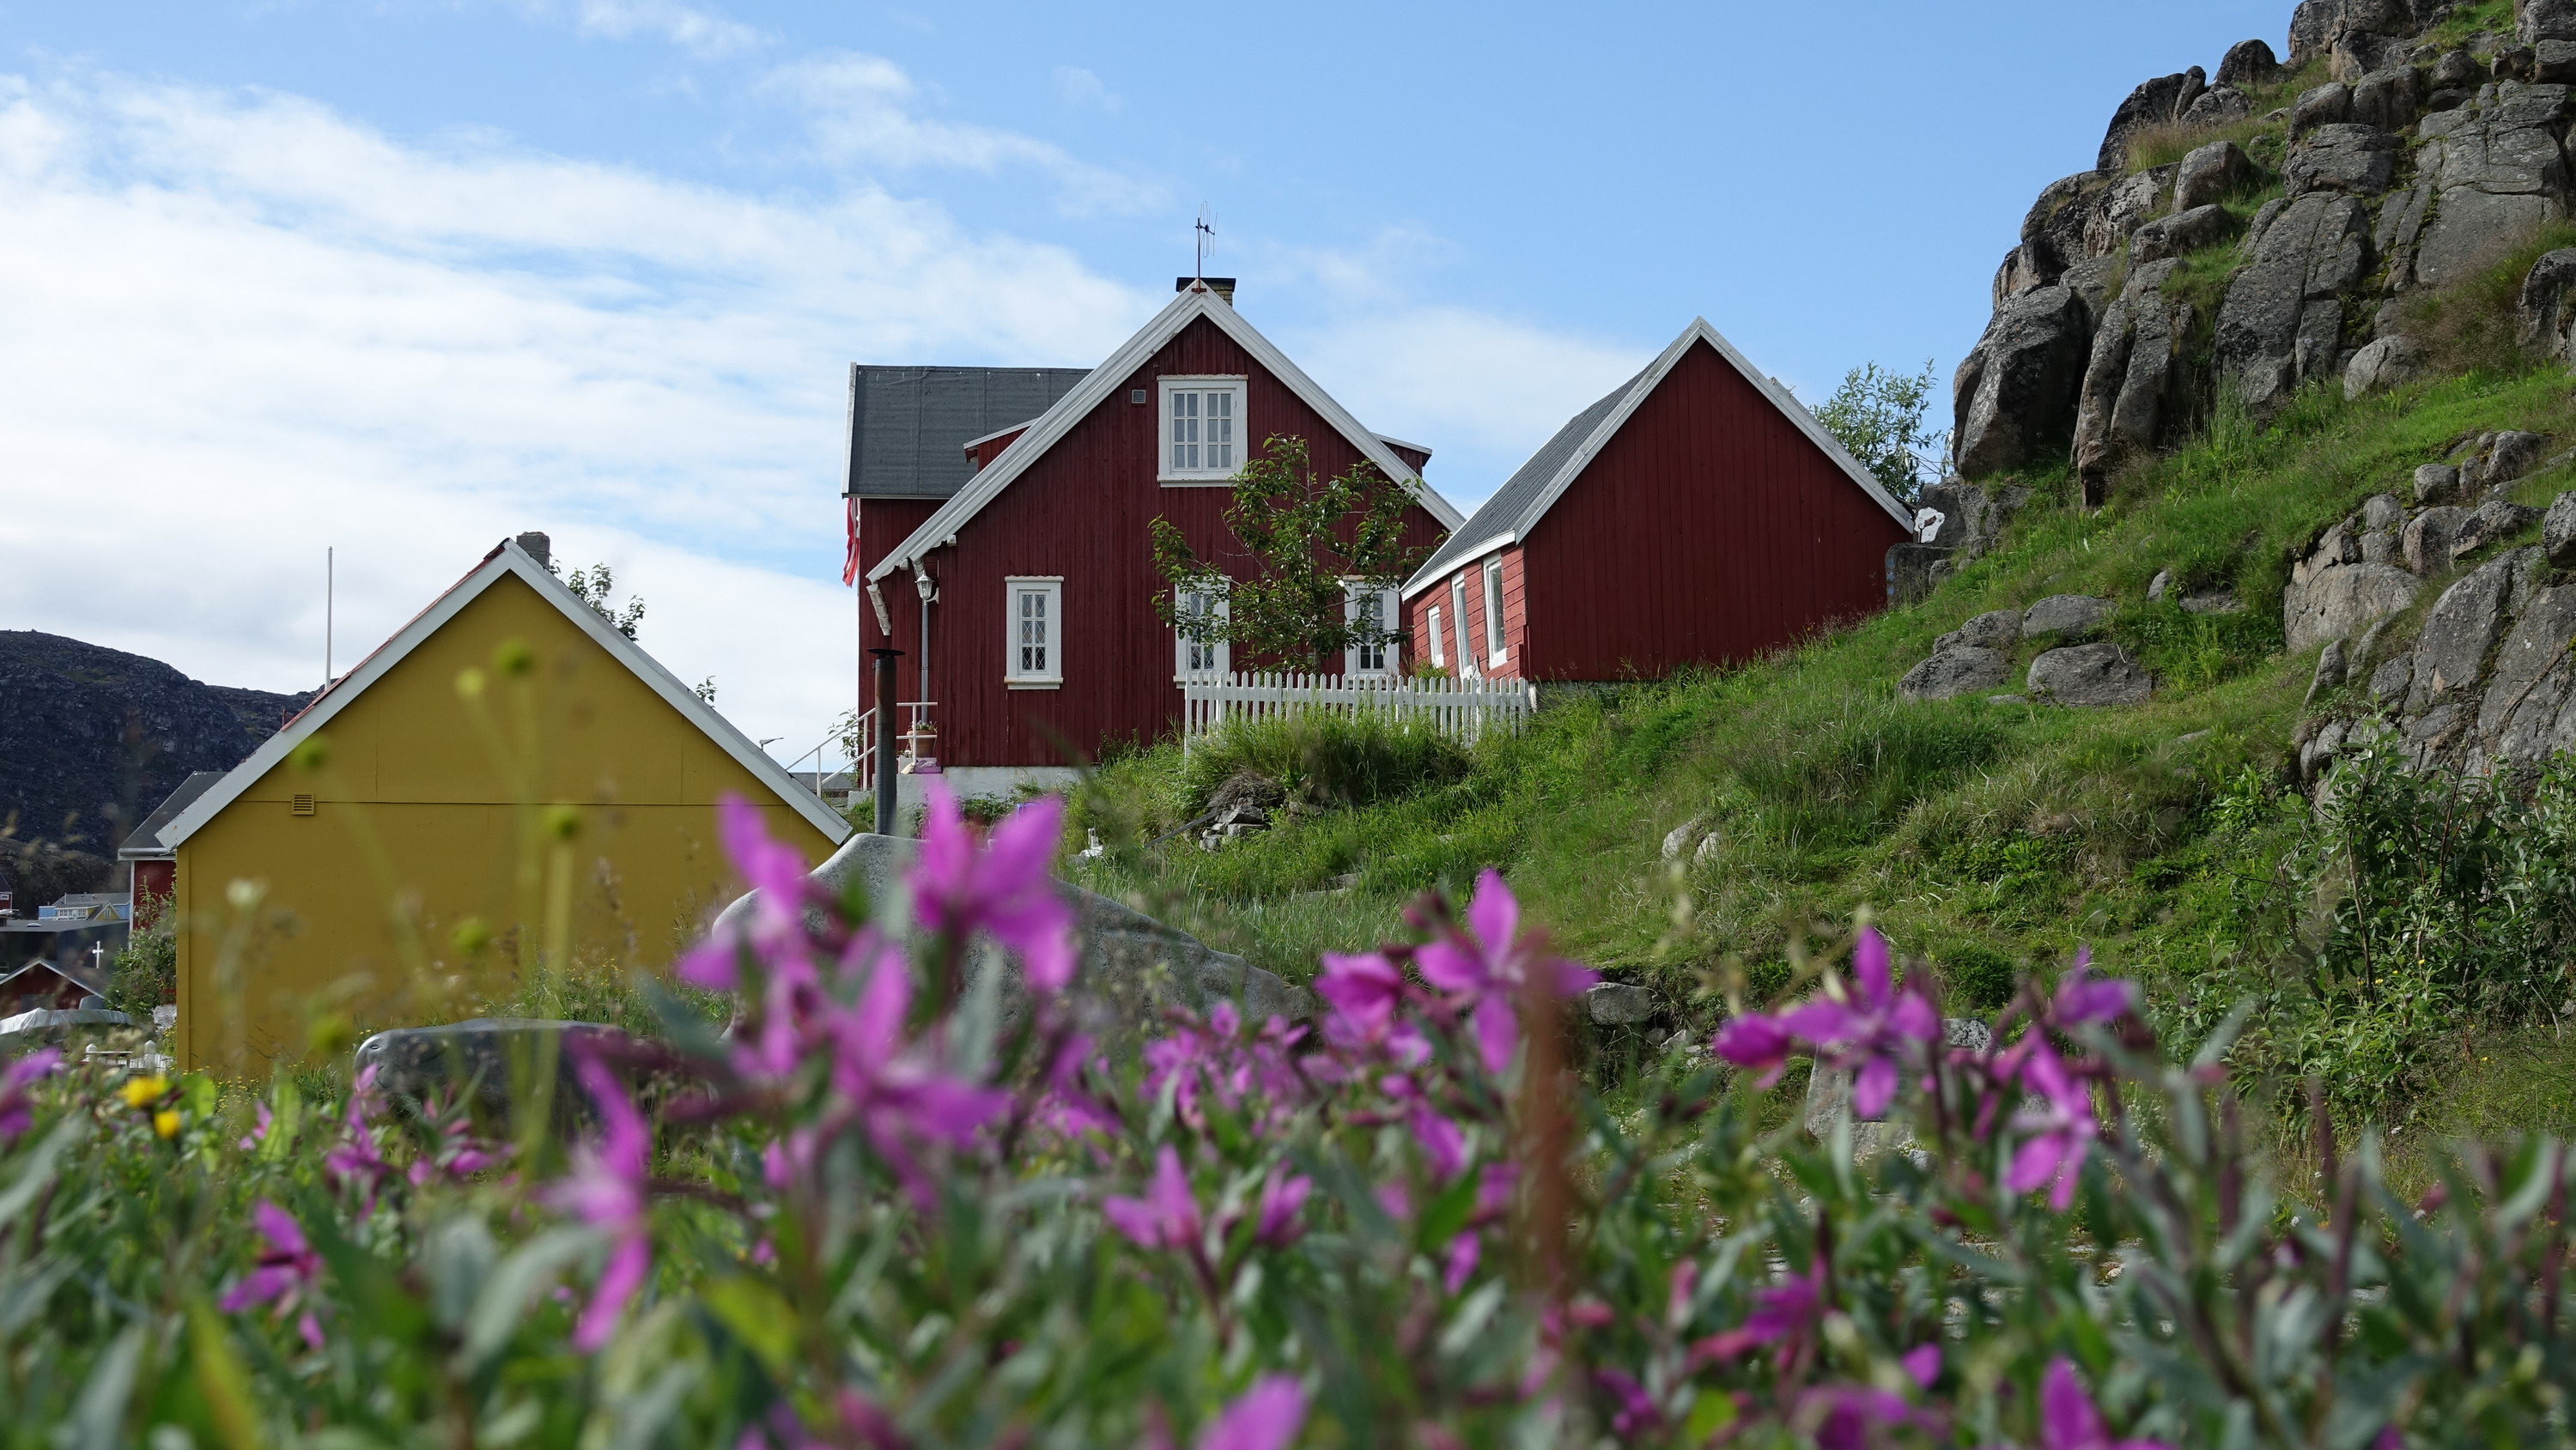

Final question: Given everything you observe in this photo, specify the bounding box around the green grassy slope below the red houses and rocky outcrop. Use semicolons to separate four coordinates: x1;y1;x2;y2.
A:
1079;371;2576;1154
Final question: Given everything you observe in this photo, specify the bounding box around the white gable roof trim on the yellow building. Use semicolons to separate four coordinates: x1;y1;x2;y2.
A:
160;538;850;847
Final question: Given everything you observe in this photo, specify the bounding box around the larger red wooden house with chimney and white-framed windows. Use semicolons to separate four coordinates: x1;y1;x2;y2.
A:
850;278;1461;793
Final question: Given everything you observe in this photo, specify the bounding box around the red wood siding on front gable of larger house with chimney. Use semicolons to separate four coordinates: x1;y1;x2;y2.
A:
912;319;1440;765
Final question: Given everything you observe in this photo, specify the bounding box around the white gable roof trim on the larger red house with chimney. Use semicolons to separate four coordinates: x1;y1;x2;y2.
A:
868;291;1466;579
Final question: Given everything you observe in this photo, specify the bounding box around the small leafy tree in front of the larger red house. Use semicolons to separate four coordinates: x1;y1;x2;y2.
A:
1151;435;1430;664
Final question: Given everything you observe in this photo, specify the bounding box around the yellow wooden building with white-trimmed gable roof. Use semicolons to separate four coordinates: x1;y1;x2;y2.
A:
162;536;848;1071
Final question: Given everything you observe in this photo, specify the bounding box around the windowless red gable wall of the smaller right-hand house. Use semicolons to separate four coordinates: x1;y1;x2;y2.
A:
1515;343;1906;680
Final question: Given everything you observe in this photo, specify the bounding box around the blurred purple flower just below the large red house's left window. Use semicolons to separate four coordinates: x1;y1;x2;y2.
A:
907;780;1074;997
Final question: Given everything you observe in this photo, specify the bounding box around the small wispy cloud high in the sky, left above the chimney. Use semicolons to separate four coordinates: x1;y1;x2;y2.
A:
762;52;1170;216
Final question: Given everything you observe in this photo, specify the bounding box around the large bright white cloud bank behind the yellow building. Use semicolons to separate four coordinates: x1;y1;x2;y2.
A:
0;77;1154;762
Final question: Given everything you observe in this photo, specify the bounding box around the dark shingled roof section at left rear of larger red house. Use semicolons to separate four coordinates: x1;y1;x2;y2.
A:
842;363;1090;500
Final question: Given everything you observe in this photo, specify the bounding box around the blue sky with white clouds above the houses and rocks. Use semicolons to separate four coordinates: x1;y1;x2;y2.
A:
0;0;2290;744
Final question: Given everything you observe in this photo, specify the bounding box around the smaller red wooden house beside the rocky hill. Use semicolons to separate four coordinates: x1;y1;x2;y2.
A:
1404;319;1914;680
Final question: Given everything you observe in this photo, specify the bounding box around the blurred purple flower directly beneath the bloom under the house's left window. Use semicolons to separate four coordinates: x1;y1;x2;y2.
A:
822;937;1010;1203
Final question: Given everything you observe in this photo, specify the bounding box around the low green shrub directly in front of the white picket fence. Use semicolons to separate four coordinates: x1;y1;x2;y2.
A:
1182;711;1468;814
